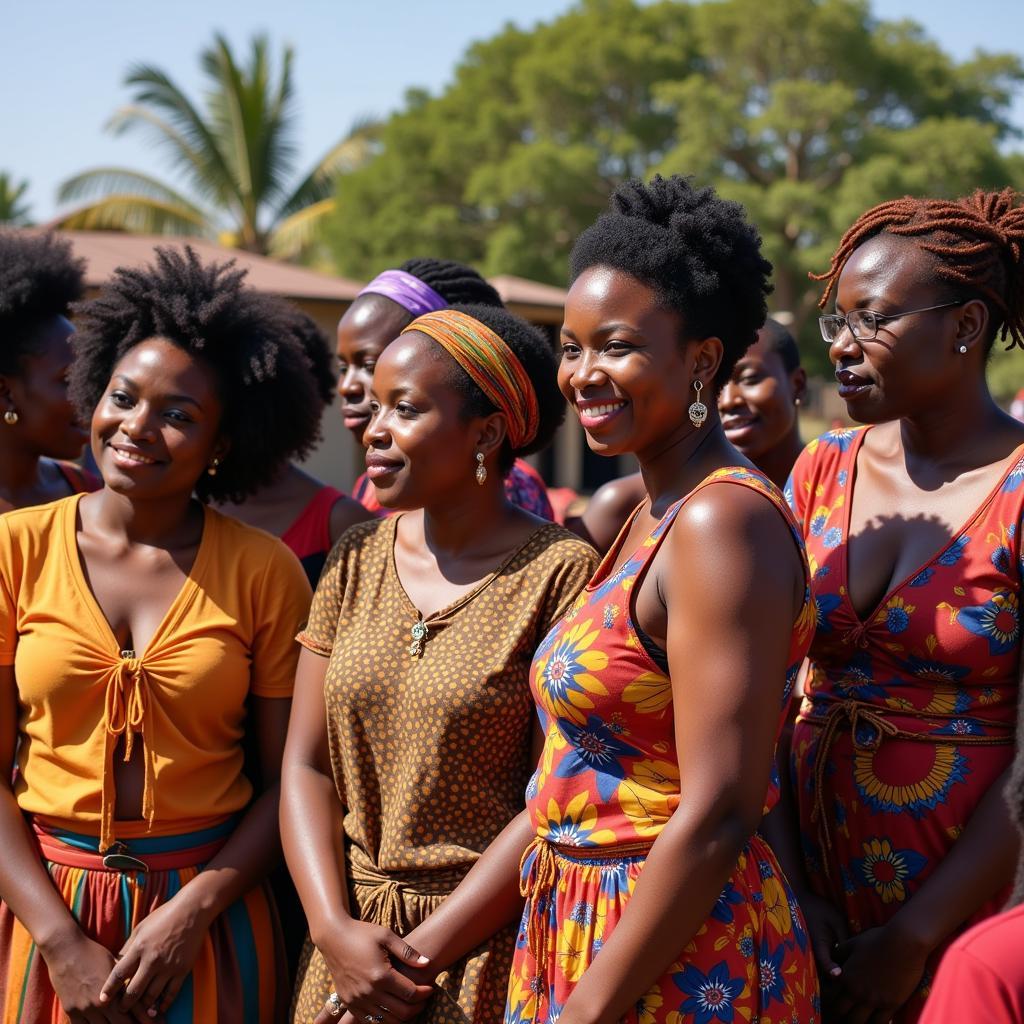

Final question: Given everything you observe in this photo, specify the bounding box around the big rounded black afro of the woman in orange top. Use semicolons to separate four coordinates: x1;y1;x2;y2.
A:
70;246;324;502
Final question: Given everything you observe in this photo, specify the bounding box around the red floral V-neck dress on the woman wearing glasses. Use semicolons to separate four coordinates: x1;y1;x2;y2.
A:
786;428;1024;1024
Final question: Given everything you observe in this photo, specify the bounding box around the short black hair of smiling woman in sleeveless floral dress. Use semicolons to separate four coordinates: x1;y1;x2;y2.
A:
569;174;772;388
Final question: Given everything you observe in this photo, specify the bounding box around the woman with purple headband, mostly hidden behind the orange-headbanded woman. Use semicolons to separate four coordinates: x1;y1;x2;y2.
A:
338;258;554;519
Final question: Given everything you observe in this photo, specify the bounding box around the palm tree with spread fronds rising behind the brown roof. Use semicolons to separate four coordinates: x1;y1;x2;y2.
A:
56;35;376;258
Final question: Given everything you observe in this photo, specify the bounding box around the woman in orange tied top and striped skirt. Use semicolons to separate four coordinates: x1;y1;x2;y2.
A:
0;250;316;1024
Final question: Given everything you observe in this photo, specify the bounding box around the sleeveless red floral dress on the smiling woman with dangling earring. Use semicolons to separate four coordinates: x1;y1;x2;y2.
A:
505;468;819;1024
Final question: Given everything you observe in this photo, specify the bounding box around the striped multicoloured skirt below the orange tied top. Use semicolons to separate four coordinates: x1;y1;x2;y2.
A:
0;820;289;1024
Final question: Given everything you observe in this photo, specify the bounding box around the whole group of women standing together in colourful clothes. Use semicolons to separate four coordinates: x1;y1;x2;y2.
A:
0;177;1024;1024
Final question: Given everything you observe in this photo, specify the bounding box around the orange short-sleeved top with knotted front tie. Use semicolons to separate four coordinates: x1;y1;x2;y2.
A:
0;496;310;849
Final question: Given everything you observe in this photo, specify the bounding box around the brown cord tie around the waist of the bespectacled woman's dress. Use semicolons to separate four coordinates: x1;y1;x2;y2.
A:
797;695;1015;878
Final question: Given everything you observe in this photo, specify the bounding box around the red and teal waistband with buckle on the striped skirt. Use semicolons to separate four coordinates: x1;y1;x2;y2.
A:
32;818;237;872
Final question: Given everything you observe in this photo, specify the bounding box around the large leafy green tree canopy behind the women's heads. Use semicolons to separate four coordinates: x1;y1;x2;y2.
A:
326;0;1024;376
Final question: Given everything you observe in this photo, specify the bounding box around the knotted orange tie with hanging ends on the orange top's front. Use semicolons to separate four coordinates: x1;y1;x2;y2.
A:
99;651;156;852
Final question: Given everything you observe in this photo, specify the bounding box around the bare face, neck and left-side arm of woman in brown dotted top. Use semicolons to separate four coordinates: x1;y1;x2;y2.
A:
281;332;541;1022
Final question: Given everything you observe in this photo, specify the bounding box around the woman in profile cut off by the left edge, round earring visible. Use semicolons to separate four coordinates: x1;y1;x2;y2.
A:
0;230;99;512
